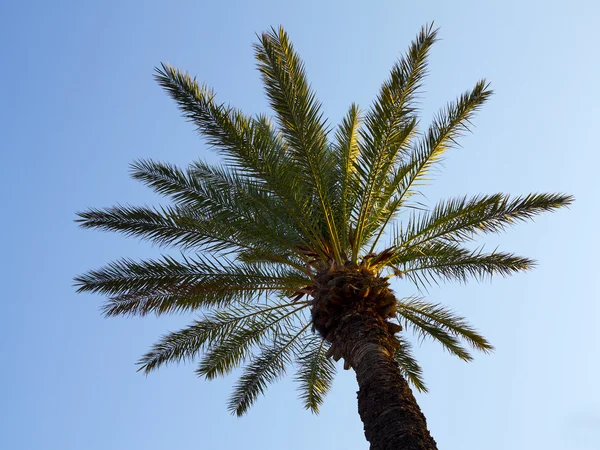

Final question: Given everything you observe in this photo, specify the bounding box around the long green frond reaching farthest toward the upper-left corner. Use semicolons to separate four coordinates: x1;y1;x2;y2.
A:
156;65;328;256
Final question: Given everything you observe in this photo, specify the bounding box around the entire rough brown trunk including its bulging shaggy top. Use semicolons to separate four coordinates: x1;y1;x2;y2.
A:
311;264;437;450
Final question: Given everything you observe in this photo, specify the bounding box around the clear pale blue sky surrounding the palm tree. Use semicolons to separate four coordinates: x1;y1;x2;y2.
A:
0;0;600;450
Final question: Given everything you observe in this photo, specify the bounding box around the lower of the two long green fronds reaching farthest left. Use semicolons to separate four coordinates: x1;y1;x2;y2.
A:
75;257;308;316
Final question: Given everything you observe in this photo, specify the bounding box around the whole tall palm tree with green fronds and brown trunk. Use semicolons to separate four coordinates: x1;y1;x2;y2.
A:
75;25;572;450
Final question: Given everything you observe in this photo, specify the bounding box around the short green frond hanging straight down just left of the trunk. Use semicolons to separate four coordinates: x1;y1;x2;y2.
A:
296;335;336;414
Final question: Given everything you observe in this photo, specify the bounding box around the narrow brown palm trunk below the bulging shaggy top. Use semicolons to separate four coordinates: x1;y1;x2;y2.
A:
334;310;437;450
